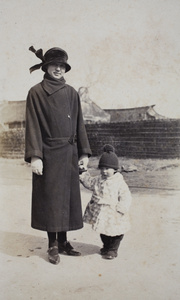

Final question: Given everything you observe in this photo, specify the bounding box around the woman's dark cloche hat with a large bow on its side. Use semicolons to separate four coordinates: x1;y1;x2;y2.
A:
29;46;71;73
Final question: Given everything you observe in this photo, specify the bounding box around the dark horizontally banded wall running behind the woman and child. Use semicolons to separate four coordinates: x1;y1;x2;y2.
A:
0;119;180;158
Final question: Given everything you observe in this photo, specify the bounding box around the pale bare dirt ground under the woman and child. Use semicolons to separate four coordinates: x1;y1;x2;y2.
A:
0;158;180;300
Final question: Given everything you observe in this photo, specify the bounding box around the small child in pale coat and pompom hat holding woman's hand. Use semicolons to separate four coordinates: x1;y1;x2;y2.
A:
80;145;131;259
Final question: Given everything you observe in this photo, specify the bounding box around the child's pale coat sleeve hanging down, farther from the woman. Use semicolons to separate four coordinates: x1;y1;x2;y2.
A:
116;178;132;214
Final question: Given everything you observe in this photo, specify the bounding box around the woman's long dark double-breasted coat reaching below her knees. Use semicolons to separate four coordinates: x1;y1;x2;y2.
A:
25;74;91;232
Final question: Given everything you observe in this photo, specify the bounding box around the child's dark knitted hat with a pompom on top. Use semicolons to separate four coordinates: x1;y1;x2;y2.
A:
98;144;119;170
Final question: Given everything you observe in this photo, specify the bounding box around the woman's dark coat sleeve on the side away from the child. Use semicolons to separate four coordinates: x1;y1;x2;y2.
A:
24;90;43;163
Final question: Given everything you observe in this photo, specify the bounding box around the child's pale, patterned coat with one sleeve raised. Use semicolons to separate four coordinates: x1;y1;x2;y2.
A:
80;172;131;236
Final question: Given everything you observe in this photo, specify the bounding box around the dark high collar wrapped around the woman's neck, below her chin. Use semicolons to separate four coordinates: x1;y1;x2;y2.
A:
41;73;66;95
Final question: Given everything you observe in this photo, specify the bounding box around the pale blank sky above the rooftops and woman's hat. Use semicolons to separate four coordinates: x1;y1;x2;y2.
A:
0;0;180;118
